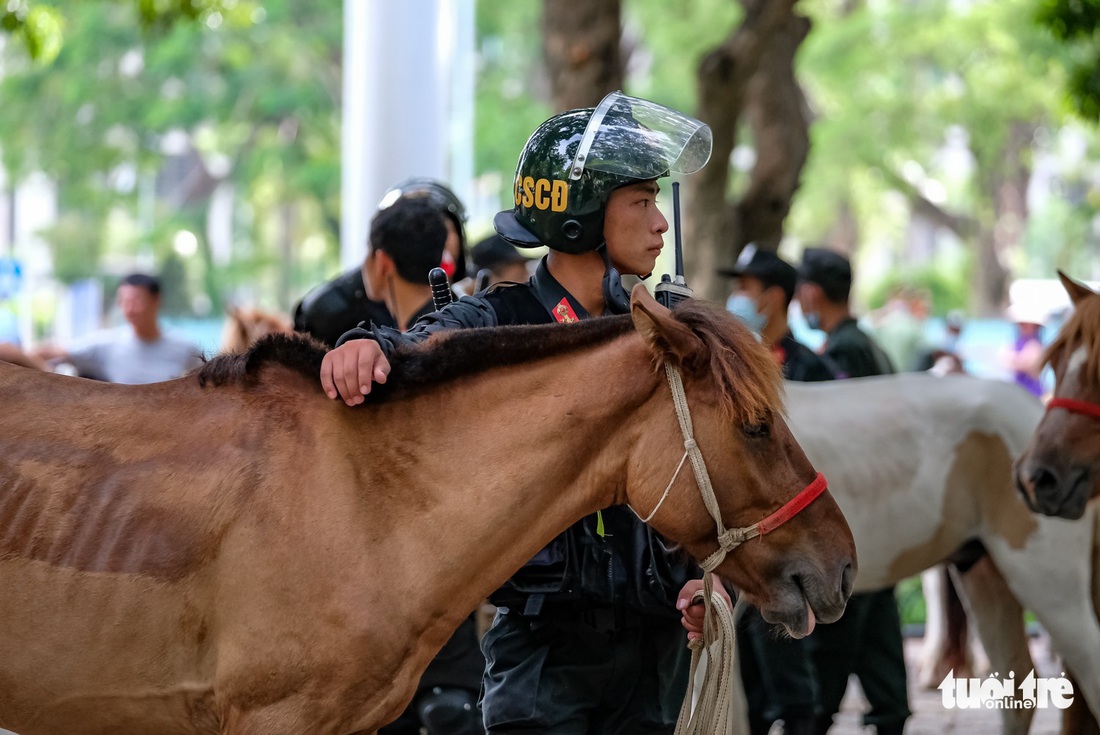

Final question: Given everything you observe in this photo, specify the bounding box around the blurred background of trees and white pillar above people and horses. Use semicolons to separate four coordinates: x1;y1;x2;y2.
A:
0;0;1100;375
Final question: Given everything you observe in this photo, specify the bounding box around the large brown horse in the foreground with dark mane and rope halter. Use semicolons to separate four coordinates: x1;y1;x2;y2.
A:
0;287;855;735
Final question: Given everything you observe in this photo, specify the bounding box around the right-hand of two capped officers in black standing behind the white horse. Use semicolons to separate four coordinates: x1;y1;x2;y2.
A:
799;248;912;735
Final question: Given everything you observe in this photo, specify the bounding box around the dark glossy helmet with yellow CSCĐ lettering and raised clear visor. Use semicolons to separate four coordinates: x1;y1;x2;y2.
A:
493;91;711;254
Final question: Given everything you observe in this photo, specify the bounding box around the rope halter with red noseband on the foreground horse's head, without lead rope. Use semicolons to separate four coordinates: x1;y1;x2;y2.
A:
636;362;828;572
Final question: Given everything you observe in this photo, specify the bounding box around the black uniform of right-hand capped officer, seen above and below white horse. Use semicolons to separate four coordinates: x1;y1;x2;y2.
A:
807;318;912;735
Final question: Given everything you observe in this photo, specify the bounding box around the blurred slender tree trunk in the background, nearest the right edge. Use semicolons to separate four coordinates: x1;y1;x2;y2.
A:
972;121;1035;317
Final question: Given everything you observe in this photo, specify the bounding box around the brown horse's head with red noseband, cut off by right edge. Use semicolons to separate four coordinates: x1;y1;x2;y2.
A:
1015;271;1100;518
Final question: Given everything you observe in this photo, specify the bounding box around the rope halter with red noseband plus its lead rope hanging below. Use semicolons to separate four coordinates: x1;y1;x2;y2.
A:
639;363;827;735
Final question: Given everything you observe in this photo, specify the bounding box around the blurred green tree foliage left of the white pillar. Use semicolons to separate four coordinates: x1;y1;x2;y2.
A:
0;0;342;306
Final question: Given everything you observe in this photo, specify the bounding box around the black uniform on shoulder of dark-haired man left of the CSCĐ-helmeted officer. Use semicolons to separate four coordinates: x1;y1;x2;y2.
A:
294;268;397;347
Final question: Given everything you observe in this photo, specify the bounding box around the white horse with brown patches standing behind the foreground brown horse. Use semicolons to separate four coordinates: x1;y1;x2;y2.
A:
787;373;1100;735
